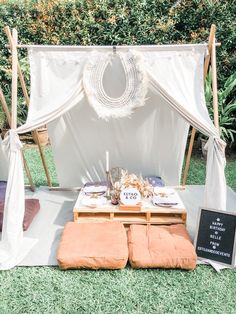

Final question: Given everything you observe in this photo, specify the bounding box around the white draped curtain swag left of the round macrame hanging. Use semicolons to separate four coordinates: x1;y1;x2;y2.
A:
17;49;88;133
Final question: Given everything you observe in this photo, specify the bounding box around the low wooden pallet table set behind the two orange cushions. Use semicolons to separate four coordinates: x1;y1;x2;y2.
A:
73;189;187;225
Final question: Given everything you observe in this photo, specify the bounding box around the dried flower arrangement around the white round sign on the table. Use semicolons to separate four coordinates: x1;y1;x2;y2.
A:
113;170;153;198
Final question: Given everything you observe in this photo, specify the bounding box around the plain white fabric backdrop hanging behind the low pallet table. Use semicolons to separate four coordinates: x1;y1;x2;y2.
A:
48;92;189;187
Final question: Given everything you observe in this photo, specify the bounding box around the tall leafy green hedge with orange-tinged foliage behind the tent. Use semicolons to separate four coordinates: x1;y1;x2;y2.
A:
0;0;236;126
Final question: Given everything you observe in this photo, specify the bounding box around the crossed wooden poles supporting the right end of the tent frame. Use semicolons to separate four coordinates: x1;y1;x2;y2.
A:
182;24;218;186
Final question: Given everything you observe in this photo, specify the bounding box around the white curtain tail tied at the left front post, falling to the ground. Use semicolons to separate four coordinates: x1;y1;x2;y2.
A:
0;130;37;270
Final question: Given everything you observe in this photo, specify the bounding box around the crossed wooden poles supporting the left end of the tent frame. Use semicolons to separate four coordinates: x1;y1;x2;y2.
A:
4;26;52;186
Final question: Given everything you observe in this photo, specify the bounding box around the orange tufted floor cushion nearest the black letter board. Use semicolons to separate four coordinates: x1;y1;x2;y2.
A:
128;224;197;269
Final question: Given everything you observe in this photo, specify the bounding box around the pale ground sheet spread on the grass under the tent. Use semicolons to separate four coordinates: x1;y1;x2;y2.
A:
7;185;236;266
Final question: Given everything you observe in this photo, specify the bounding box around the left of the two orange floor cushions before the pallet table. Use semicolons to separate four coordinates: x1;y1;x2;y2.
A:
57;222;128;269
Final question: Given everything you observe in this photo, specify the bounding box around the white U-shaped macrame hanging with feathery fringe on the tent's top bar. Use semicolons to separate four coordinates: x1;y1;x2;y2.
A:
83;51;147;120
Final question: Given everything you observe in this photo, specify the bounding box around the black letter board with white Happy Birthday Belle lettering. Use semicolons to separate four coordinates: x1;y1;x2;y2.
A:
195;208;236;266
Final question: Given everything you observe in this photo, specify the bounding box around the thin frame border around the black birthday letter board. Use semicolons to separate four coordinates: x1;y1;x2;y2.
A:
194;207;236;267
